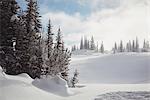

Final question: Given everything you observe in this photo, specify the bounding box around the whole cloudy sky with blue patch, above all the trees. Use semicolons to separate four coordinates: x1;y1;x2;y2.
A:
17;0;150;50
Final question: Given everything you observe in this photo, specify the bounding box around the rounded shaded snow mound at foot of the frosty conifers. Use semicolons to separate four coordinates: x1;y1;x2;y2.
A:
32;76;74;96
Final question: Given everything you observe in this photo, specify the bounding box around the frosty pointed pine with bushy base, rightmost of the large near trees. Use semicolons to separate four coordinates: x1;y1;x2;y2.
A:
47;28;71;81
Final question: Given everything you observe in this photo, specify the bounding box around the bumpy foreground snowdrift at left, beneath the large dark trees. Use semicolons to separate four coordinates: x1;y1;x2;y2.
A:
0;67;73;100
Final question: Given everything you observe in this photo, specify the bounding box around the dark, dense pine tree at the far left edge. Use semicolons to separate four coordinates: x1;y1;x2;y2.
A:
0;0;19;74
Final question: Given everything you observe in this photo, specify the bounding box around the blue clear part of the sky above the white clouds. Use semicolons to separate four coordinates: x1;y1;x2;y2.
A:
17;0;91;16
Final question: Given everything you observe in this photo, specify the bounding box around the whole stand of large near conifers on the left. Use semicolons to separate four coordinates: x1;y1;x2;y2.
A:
0;0;71;80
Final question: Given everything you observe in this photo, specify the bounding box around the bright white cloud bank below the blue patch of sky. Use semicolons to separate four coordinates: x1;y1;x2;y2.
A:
43;0;150;49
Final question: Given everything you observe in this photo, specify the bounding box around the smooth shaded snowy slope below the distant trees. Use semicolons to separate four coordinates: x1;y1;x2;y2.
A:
70;53;150;84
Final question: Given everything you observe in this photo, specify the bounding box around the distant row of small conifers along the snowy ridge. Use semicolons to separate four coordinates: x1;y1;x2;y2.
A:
71;36;150;53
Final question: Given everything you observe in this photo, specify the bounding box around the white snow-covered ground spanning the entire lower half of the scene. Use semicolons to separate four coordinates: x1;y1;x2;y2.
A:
0;53;150;100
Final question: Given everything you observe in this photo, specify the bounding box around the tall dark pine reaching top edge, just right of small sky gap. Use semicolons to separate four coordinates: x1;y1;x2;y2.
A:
26;0;43;78
